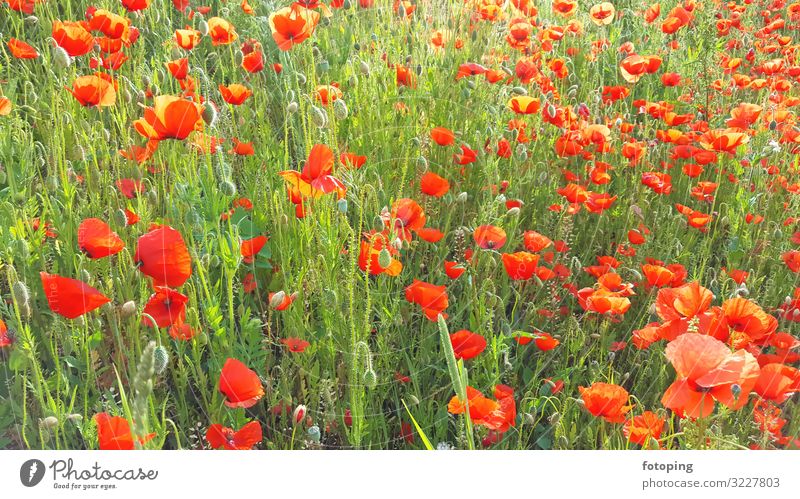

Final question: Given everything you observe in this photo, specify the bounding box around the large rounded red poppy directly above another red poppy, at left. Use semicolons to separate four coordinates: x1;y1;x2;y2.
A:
133;225;192;288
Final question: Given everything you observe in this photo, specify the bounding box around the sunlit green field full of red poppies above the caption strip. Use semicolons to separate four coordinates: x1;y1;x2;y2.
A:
0;0;800;450
